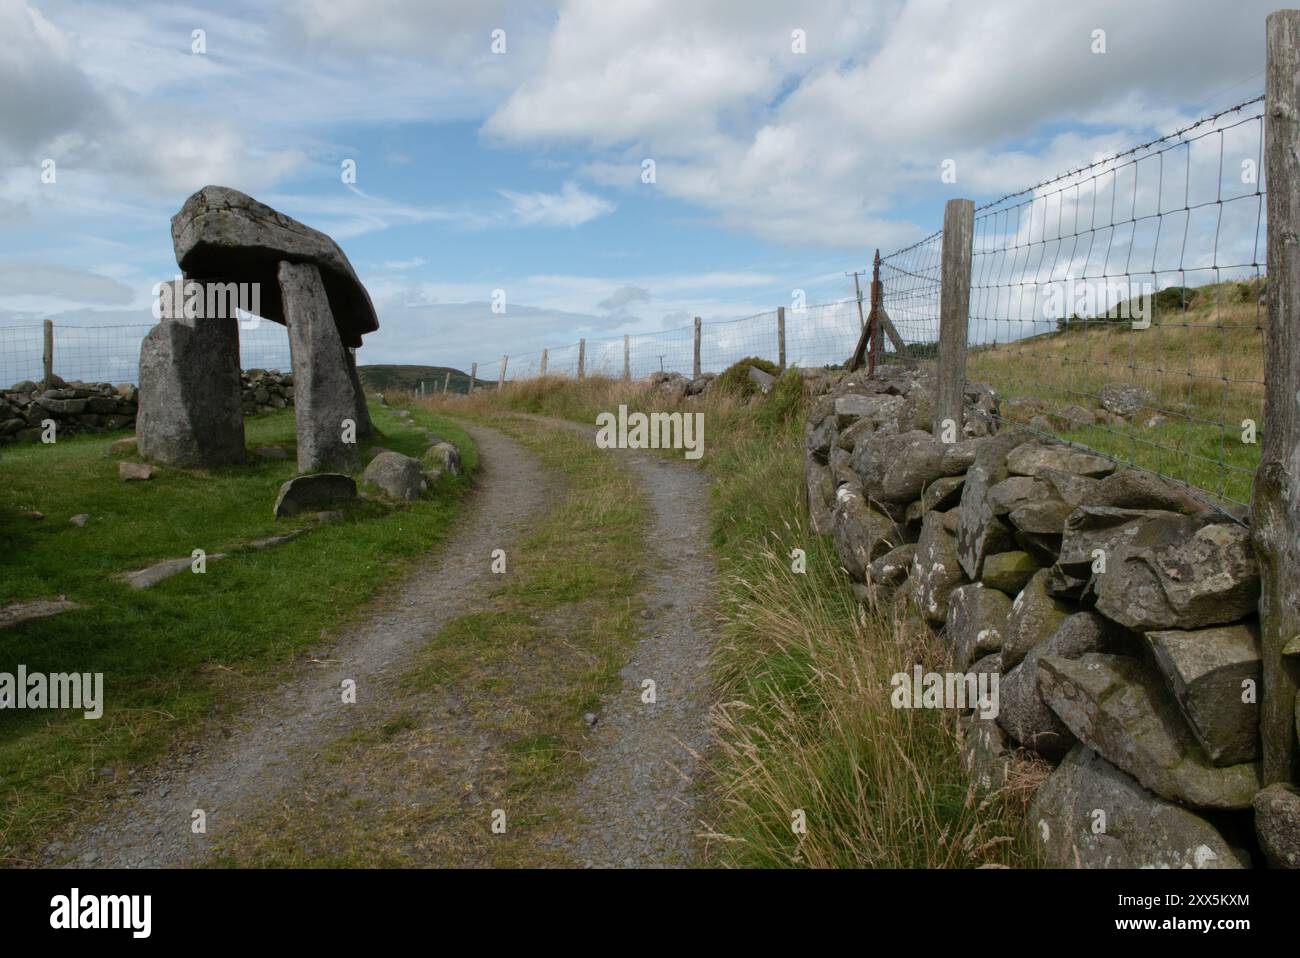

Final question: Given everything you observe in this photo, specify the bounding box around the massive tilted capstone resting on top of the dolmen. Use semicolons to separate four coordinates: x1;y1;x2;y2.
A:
172;186;380;347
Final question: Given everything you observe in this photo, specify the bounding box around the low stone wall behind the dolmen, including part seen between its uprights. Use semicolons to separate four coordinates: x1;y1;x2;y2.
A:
0;369;294;445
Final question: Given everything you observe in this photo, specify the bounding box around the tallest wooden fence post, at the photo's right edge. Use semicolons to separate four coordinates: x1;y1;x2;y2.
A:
1251;10;1300;785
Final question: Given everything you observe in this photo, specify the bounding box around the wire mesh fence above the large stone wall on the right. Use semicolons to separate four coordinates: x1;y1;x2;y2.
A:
881;97;1266;506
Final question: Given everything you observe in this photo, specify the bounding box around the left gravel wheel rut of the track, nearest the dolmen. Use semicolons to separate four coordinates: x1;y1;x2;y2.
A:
44;425;553;868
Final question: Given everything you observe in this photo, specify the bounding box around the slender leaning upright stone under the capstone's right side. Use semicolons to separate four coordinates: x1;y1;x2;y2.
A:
278;263;360;472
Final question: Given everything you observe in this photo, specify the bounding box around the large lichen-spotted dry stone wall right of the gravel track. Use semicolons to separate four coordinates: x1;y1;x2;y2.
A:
805;367;1300;868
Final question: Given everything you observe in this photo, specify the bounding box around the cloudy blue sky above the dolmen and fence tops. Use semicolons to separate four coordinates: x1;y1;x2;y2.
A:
0;0;1277;368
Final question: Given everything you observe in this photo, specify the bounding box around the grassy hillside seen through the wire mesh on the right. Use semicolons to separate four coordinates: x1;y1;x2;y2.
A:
967;274;1266;503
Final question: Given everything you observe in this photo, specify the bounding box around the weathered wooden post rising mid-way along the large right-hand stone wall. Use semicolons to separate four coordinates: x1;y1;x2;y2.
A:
935;200;975;437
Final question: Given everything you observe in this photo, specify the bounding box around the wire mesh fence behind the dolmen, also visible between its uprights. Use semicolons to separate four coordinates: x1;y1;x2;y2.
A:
0;318;291;387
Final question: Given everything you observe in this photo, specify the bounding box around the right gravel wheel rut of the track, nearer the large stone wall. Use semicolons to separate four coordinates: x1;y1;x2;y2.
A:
517;417;716;868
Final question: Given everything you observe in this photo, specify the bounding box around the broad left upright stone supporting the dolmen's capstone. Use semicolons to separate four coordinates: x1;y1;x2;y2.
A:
135;278;244;468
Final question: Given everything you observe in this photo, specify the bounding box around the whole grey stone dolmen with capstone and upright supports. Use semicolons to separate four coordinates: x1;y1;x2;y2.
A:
137;186;380;473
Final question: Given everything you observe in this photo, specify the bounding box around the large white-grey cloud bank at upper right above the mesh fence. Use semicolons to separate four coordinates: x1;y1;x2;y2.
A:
485;0;1271;248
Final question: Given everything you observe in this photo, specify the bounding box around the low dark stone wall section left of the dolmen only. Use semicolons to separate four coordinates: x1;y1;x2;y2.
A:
0;377;135;443
